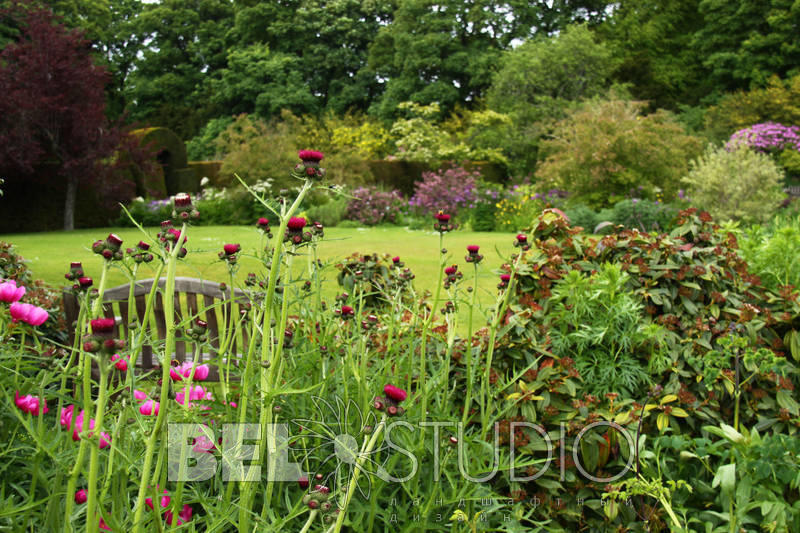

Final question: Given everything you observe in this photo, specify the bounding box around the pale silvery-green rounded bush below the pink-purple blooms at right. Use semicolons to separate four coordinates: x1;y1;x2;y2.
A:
681;145;784;222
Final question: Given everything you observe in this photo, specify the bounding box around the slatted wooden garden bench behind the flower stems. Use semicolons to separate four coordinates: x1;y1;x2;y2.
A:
63;277;249;381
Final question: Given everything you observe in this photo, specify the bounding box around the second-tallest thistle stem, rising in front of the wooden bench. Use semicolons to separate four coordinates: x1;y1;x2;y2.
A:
133;223;186;533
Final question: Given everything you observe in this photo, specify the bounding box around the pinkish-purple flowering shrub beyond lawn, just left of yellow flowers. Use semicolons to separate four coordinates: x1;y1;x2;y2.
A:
408;166;481;215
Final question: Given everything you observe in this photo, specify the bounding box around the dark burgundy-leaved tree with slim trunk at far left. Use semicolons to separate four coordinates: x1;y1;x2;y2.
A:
0;4;120;229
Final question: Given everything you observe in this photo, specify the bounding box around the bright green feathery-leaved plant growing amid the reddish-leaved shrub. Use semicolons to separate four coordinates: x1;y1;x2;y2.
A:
545;264;650;397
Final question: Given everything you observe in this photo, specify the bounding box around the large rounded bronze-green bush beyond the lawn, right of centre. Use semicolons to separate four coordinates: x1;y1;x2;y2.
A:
536;100;701;207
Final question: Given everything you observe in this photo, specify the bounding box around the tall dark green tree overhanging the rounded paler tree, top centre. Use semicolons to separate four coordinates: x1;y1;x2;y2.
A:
369;0;606;119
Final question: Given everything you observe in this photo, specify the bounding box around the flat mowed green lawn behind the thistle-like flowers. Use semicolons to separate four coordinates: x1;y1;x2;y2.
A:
0;226;515;330
